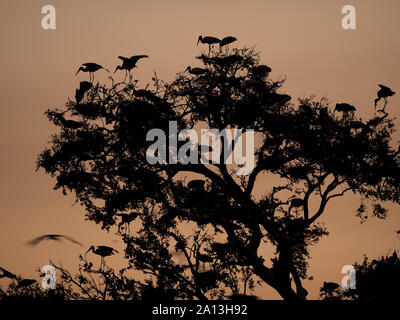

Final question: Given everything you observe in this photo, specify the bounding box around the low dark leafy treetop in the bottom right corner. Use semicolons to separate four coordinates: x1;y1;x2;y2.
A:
320;252;400;302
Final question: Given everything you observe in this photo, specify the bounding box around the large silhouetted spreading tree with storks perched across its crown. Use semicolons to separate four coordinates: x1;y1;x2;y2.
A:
37;48;400;300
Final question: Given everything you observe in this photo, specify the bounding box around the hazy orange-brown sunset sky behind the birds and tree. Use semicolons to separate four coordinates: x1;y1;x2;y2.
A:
0;0;400;299
